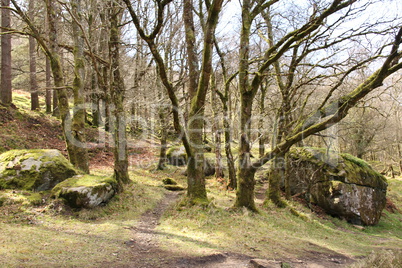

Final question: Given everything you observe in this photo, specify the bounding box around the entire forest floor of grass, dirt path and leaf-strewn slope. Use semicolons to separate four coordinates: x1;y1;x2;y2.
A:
0;92;402;267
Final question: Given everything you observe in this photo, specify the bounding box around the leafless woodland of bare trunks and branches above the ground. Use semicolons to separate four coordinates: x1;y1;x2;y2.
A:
1;0;402;210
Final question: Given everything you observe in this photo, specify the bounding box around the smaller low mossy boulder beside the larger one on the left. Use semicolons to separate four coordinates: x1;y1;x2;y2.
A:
52;175;117;208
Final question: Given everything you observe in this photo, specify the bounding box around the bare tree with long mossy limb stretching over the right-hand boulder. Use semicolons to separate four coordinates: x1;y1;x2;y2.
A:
235;0;402;210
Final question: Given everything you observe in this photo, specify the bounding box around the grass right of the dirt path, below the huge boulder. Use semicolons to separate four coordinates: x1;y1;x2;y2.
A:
158;177;402;259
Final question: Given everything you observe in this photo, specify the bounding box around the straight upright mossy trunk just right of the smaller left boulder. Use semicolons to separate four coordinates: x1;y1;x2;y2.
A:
109;1;130;190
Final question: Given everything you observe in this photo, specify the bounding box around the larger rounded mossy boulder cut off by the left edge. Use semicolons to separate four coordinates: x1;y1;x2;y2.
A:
0;150;77;191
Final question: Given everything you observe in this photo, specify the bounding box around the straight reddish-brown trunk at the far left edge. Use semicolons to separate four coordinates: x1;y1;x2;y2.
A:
0;0;12;106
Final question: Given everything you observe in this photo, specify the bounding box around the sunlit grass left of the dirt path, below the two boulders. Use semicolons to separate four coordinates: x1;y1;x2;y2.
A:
0;171;164;267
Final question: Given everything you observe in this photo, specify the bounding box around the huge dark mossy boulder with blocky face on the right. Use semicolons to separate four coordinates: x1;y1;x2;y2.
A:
288;148;387;225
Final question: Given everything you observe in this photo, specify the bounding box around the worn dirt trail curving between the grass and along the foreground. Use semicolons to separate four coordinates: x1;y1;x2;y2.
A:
125;192;354;268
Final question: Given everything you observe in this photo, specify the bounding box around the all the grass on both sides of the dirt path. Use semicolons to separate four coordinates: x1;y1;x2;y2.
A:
0;93;402;267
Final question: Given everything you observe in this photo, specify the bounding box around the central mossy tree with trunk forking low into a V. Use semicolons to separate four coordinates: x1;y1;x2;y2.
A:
124;0;223;203
